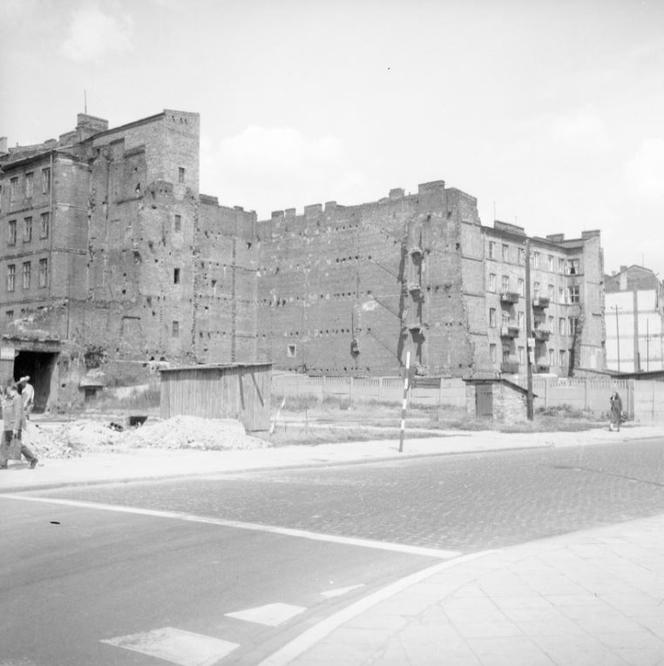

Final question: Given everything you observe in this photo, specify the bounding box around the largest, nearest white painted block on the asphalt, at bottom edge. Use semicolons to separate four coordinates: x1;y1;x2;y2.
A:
101;627;239;666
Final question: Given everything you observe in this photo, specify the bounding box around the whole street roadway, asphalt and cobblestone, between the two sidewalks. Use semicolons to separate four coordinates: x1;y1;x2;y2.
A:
0;440;664;666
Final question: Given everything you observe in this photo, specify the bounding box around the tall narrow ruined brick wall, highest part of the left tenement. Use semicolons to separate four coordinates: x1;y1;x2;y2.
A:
82;112;199;360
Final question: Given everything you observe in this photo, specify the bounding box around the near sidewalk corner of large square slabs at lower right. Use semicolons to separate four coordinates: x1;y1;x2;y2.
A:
278;516;664;666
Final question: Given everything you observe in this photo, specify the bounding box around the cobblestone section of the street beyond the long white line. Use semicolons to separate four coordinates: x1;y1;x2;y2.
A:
37;440;664;553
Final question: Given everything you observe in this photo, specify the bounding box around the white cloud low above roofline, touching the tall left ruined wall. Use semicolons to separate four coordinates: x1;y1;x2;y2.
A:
201;126;367;216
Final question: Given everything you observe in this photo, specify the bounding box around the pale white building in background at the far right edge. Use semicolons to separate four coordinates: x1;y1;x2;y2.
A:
604;265;664;372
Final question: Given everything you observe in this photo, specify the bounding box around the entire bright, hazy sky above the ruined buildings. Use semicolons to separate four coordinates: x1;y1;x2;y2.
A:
0;0;664;277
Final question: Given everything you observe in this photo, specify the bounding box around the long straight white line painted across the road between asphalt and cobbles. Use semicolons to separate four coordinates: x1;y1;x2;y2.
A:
0;493;461;560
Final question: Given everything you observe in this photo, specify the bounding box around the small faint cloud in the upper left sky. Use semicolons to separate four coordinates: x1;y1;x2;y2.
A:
61;7;133;62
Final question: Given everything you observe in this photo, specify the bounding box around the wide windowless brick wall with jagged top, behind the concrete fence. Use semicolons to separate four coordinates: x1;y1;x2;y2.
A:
258;181;477;374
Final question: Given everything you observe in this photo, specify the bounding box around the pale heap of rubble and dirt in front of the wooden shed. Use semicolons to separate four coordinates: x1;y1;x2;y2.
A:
24;416;268;458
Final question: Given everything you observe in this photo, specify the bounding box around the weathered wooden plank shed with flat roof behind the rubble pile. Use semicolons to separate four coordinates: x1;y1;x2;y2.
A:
160;363;272;431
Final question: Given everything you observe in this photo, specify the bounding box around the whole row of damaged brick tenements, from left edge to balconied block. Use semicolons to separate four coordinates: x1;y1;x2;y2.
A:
0;110;604;409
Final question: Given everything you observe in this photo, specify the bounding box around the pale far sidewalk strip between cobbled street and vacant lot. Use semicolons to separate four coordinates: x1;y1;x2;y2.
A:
0;425;664;492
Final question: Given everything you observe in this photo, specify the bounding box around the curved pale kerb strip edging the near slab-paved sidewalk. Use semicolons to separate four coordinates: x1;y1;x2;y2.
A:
258;550;493;666
